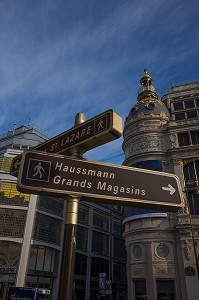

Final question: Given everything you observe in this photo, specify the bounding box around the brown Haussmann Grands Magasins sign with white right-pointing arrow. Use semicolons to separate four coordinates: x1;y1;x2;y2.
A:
18;150;183;211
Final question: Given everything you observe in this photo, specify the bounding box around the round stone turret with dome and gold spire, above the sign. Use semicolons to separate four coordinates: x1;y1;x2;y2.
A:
123;70;170;166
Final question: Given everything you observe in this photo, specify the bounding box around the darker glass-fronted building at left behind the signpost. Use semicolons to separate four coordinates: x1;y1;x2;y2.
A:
0;126;126;300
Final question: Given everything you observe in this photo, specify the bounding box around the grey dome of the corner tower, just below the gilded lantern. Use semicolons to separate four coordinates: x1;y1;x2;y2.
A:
126;100;170;121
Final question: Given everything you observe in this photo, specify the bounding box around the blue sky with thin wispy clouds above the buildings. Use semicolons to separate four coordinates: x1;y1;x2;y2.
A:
0;0;199;163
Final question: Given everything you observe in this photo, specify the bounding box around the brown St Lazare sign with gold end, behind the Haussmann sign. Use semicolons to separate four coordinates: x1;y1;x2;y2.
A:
10;109;122;176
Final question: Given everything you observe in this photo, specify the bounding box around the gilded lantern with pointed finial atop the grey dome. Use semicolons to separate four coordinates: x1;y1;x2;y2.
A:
137;69;158;102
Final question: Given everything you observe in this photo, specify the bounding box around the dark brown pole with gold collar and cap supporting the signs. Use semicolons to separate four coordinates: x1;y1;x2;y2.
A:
58;113;85;300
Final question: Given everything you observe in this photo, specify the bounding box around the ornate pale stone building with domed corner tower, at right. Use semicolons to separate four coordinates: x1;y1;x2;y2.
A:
123;70;199;300
